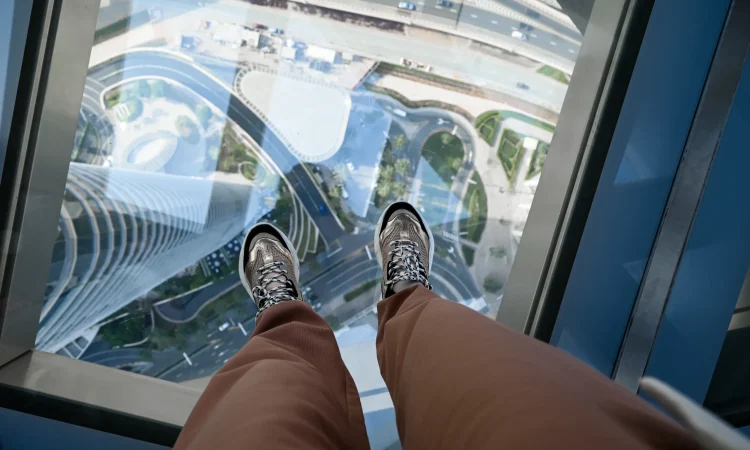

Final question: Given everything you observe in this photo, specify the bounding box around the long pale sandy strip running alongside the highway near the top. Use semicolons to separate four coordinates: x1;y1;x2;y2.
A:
129;0;575;109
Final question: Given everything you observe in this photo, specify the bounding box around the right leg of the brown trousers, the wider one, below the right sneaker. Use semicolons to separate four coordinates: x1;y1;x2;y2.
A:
377;286;697;450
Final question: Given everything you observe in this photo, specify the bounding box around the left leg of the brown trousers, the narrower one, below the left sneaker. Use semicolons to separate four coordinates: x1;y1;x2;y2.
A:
175;301;369;450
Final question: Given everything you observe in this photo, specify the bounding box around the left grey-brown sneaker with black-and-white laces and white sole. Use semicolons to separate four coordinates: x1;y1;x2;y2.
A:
239;223;304;314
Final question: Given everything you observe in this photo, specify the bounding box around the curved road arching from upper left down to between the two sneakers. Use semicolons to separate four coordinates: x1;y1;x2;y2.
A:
93;57;343;242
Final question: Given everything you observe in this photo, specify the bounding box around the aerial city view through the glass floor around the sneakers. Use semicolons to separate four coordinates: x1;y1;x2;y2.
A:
37;0;582;426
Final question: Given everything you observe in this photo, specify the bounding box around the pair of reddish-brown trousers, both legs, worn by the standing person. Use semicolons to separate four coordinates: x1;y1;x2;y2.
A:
175;287;698;450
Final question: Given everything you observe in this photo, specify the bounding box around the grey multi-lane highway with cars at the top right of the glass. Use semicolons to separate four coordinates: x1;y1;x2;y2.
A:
366;0;581;61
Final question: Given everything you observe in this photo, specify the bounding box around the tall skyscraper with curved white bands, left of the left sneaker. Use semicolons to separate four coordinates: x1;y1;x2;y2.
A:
36;163;260;352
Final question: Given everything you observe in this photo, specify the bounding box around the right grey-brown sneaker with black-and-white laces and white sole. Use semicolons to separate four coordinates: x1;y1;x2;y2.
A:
375;202;435;298
